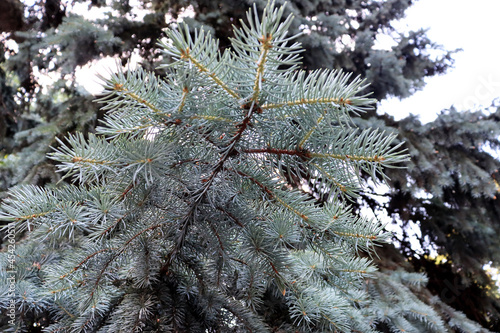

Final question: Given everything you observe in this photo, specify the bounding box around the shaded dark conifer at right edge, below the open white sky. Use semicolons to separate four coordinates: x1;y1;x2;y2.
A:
356;104;500;331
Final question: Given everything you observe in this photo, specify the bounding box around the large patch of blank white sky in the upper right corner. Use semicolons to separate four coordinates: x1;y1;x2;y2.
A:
379;0;500;122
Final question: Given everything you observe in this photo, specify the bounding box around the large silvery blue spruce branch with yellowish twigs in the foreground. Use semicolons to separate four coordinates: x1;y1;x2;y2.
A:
0;5;408;332
